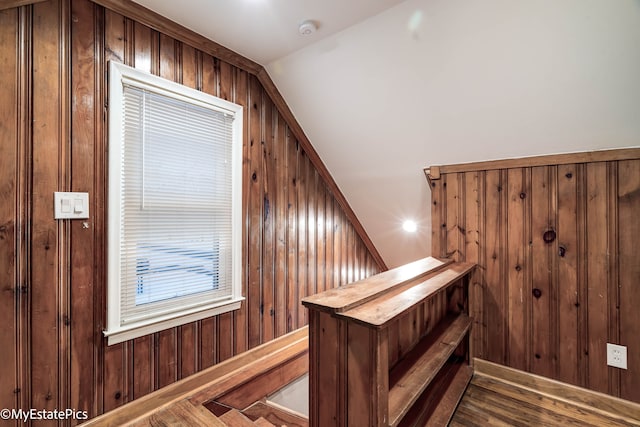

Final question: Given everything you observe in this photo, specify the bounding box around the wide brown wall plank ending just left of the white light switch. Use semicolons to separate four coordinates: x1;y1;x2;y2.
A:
29;1;67;409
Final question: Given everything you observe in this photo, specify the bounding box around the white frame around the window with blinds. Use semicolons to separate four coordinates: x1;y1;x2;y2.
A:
104;61;244;345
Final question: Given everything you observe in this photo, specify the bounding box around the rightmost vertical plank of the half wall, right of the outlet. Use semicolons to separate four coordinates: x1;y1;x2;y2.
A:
617;160;640;402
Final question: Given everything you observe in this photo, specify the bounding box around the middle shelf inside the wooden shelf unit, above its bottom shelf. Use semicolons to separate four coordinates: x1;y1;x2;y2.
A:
389;314;471;427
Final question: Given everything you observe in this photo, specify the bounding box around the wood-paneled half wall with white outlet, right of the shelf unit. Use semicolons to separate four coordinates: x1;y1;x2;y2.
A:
425;148;640;402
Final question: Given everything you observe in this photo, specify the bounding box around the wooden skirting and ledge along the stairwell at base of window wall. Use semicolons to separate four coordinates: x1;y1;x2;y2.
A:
83;327;308;427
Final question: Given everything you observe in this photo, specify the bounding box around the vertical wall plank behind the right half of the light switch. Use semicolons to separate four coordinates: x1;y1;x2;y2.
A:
69;0;101;414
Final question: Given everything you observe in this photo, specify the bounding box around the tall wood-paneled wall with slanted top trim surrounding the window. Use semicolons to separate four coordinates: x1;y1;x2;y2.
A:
0;0;386;425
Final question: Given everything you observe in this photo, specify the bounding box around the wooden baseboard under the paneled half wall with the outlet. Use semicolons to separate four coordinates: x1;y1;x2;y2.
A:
473;358;640;424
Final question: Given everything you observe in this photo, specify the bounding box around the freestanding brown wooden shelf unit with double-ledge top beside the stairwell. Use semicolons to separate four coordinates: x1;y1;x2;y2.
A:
302;257;475;427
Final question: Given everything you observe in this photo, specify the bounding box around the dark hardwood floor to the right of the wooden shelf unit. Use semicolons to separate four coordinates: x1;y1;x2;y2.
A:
449;362;640;427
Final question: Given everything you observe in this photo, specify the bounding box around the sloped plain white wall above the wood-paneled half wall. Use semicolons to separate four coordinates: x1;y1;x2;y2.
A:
267;0;640;266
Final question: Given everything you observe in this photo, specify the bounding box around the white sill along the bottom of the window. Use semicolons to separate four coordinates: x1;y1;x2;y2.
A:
103;298;244;345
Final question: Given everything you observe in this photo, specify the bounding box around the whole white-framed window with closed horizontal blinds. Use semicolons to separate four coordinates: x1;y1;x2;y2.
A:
104;62;242;345
